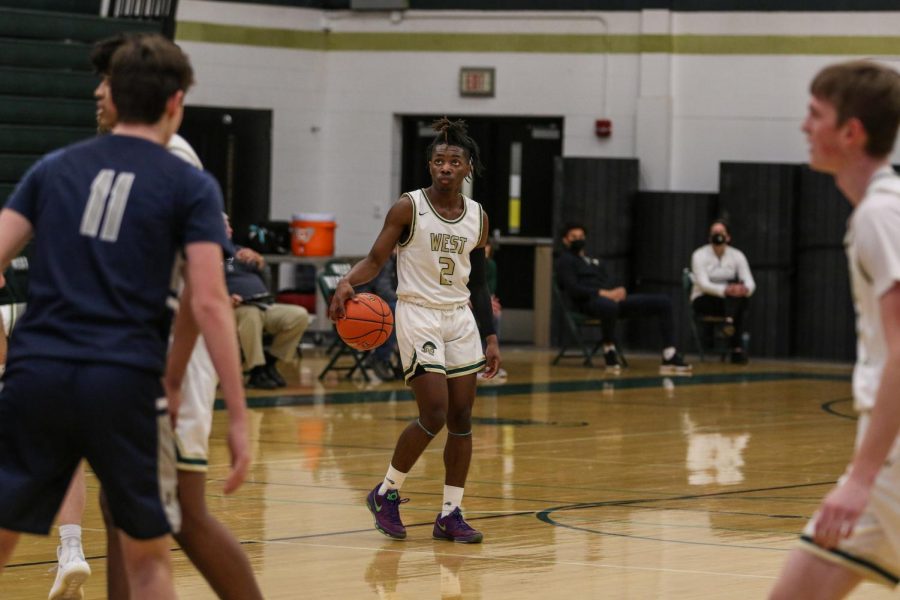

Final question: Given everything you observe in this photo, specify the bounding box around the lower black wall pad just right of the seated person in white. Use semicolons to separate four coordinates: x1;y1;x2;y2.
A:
747;263;792;358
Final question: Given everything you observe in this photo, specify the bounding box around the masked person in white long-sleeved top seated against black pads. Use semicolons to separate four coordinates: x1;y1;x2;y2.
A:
691;221;756;365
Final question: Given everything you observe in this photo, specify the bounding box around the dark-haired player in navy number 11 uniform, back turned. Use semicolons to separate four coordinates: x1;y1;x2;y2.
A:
0;36;250;599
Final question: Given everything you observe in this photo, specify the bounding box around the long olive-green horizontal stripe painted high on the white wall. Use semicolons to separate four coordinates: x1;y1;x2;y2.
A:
176;21;900;56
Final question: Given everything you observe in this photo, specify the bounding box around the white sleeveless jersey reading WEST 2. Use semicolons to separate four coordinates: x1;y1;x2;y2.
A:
397;190;484;308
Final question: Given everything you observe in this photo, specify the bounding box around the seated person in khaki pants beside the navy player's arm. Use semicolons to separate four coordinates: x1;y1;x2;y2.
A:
225;216;309;390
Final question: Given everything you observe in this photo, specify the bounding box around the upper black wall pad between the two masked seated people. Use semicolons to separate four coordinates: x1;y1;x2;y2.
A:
632;192;718;286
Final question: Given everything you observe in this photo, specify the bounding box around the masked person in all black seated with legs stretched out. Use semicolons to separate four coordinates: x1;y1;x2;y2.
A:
554;223;691;374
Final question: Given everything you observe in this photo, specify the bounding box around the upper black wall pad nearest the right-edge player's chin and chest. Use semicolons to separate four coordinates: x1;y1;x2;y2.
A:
794;166;851;252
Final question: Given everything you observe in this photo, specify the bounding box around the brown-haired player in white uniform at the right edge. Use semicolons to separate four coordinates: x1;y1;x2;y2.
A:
771;61;900;600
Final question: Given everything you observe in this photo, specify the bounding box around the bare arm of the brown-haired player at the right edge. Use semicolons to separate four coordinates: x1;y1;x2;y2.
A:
815;282;900;548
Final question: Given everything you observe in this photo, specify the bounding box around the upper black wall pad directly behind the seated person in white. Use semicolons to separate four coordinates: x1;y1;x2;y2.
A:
719;163;799;270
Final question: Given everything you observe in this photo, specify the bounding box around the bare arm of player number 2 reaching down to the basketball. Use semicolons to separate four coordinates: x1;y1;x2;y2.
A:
328;196;413;320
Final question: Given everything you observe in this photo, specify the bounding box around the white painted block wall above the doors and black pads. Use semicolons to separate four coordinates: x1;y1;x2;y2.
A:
177;0;900;254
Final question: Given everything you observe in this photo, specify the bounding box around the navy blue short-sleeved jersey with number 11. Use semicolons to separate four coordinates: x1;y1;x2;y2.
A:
6;135;229;372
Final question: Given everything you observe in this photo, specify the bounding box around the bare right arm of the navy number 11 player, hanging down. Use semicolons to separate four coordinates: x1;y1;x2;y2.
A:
182;242;250;493
